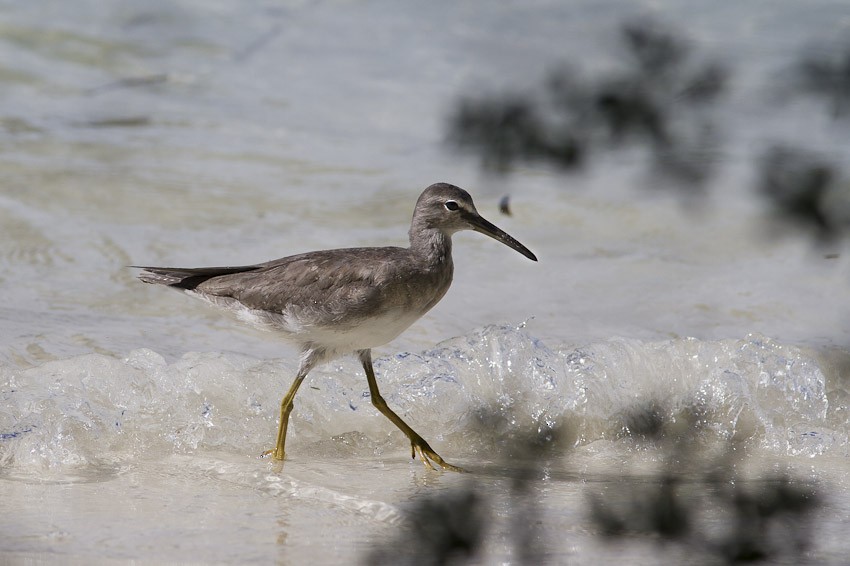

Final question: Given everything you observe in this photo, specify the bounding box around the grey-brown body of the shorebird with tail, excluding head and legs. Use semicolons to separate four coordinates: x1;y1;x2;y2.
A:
134;247;453;352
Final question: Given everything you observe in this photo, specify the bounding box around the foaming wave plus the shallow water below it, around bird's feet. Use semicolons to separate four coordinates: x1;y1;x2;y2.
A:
0;327;848;563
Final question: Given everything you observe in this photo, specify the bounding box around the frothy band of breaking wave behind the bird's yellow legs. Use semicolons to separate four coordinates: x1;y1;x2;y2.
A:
0;326;850;479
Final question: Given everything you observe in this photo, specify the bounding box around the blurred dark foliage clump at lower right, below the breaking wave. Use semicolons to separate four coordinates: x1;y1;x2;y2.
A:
589;404;820;564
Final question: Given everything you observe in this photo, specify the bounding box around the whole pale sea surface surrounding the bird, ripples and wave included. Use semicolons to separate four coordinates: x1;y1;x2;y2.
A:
0;0;850;564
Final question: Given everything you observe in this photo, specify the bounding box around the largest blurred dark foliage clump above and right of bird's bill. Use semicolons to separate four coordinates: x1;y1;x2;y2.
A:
449;23;727;189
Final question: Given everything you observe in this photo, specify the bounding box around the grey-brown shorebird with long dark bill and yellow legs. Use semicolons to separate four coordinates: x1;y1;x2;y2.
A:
133;183;537;471
